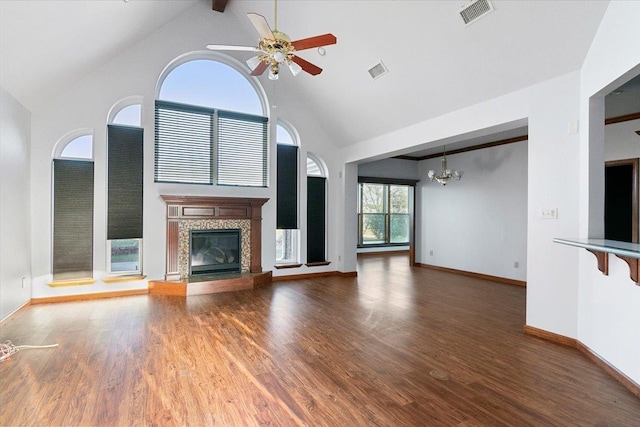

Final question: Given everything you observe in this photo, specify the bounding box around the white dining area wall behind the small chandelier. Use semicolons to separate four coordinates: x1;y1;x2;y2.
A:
416;141;527;281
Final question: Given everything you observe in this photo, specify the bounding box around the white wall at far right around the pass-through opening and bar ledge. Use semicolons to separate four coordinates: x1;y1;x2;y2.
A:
567;1;640;384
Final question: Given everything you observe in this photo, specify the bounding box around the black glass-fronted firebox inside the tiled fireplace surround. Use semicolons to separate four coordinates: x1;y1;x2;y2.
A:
189;229;242;277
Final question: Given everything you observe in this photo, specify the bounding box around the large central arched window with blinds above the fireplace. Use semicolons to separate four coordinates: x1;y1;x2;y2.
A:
155;56;268;187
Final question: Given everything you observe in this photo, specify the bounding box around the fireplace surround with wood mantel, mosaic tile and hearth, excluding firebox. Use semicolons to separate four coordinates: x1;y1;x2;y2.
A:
150;195;271;295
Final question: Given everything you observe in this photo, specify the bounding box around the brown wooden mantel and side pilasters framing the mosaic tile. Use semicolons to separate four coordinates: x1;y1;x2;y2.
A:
161;195;269;280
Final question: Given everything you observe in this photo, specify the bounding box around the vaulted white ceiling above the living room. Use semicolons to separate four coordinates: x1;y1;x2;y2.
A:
0;0;608;146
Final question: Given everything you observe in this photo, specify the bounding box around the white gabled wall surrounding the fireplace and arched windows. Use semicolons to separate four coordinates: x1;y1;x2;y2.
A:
26;2;342;298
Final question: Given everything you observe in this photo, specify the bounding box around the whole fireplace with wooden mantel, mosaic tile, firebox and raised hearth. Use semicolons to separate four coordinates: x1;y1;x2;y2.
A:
149;195;271;296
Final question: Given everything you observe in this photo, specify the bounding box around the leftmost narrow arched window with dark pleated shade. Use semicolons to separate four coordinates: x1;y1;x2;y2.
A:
52;131;94;281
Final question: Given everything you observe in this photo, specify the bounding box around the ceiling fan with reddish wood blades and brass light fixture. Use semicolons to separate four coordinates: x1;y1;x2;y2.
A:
207;0;337;80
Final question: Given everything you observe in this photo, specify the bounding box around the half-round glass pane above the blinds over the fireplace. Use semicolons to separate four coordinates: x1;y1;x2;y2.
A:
159;59;264;115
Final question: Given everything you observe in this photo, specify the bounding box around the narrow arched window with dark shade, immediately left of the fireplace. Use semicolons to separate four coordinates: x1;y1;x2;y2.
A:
107;100;144;276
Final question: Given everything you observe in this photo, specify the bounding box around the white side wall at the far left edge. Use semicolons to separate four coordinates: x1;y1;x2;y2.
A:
0;88;31;320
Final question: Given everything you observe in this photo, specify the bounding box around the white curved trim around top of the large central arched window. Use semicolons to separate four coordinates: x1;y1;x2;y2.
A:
155;51;271;118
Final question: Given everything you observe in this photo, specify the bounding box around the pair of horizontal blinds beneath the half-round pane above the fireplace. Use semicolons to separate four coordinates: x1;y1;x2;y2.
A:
155;101;269;187
